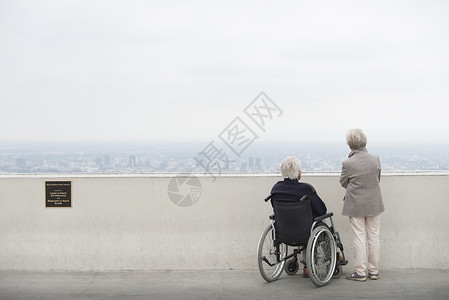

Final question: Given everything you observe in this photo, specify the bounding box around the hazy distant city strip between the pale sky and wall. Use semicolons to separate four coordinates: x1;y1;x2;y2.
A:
0;141;449;173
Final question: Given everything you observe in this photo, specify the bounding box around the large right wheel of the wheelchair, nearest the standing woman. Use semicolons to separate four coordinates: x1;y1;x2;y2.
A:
306;225;337;287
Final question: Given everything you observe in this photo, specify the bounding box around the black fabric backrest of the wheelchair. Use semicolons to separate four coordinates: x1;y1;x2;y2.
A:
271;194;313;246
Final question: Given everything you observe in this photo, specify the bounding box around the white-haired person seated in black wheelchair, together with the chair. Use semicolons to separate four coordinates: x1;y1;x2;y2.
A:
258;156;347;286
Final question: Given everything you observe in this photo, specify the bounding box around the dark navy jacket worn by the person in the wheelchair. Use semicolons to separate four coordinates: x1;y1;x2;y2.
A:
271;178;327;217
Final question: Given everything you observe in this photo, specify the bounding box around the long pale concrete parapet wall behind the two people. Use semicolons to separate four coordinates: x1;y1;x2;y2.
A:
0;174;449;270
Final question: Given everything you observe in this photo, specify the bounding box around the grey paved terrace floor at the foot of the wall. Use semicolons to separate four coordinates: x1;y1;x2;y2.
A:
0;270;449;300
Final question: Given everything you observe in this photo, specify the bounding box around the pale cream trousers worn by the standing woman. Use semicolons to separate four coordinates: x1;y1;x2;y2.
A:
349;215;380;276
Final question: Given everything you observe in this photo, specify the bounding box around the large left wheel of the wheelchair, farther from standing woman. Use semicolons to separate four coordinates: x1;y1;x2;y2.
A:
257;225;287;282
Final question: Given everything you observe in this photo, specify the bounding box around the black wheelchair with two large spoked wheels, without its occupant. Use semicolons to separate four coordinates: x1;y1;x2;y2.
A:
257;195;348;287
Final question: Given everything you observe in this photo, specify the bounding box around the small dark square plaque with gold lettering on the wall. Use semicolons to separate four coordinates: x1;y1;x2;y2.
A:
45;181;72;207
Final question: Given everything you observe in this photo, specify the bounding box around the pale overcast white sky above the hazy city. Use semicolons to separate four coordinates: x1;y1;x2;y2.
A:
0;0;449;142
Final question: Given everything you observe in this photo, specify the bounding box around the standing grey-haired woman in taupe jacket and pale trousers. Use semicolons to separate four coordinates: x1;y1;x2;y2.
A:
340;129;384;281
